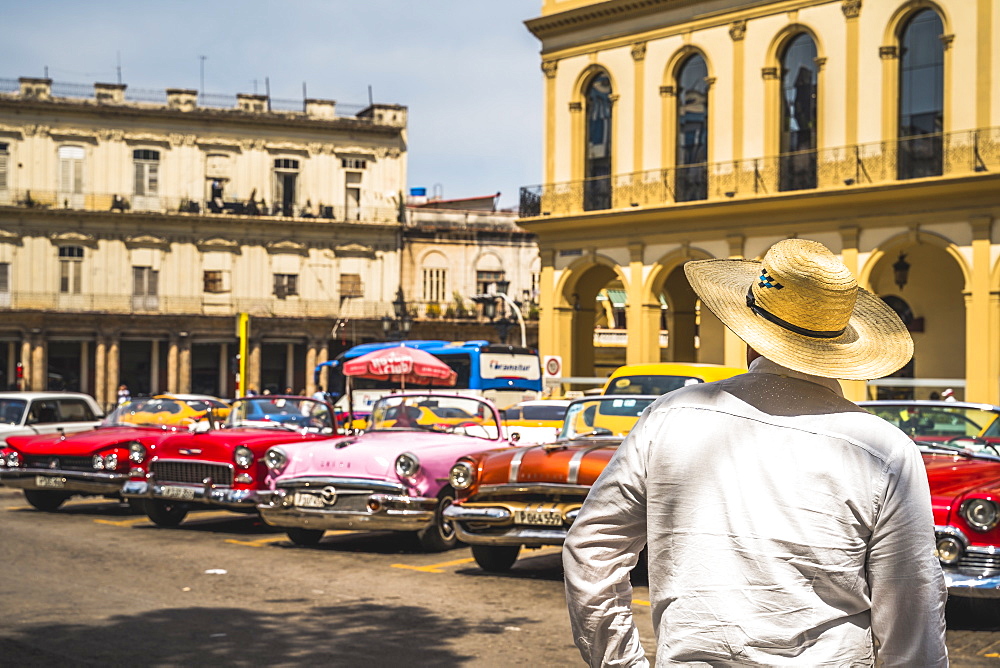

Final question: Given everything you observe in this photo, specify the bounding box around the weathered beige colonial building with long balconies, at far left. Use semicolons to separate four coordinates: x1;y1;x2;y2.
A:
0;73;407;405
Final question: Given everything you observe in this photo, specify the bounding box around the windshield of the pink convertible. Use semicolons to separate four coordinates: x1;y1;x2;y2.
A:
369;394;500;439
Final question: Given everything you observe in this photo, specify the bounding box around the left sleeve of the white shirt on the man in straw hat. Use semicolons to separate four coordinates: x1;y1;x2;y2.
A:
563;411;649;667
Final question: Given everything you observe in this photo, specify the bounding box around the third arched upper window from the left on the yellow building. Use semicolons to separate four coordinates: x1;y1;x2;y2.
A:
778;33;817;190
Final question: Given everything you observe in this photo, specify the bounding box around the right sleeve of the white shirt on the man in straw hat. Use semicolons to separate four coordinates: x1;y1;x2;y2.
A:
868;439;948;666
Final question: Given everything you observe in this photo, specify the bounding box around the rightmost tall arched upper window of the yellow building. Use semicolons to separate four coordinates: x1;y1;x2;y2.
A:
897;9;944;179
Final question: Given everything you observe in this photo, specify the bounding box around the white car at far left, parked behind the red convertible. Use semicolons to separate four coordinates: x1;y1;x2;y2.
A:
0;392;104;445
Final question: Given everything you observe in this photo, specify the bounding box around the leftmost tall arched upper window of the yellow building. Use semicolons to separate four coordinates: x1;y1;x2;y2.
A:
583;72;611;211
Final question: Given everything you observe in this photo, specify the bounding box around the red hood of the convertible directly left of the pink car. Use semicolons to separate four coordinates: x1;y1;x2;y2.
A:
156;429;330;463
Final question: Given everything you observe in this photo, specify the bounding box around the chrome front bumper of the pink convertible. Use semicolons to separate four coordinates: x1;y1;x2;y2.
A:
257;489;438;531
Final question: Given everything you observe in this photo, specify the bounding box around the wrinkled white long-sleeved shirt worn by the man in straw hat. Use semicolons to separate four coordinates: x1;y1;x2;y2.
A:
563;358;948;667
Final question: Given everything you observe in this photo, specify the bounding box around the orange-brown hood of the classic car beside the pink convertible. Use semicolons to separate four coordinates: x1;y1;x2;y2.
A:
479;439;621;485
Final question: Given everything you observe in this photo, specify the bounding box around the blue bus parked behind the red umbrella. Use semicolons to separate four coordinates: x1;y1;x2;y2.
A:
314;340;542;415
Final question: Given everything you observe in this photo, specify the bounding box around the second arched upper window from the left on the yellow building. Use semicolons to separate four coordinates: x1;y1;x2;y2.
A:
674;54;708;202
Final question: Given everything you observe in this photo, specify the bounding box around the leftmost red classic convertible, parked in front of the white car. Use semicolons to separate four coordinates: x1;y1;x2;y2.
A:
0;397;204;512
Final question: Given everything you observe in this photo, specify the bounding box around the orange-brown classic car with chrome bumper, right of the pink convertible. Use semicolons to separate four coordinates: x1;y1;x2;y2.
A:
444;395;658;572
